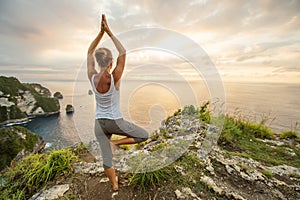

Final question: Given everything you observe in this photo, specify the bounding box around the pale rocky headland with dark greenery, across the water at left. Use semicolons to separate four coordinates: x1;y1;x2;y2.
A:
0;76;60;125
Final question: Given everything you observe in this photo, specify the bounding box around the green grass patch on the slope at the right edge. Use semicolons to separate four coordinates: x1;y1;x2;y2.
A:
214;111;300;168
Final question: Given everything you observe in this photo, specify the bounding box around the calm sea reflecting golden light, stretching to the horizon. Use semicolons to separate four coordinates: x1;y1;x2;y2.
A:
18;80;300;148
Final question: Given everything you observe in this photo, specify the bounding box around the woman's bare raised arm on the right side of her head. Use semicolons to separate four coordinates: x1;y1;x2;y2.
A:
102;16;126;85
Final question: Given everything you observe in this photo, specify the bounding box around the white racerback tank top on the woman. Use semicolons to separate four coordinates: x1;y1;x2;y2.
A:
92;74;122;119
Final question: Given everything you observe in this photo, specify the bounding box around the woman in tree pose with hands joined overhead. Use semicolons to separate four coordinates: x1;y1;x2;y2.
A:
87;15;148;191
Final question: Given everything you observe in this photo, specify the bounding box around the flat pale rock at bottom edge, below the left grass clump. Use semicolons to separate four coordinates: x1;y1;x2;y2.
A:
29;184;70;200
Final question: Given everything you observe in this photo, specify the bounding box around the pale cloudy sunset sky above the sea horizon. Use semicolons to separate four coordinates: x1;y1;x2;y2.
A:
0;0;300;84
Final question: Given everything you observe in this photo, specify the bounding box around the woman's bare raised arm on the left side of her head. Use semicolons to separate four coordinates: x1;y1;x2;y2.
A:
87;15;104;80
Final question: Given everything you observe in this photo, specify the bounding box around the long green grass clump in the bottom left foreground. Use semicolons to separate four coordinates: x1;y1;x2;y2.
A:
0;149;77;200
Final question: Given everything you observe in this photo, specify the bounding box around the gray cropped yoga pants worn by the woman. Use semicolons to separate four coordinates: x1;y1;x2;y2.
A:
95;119;148;168
